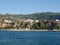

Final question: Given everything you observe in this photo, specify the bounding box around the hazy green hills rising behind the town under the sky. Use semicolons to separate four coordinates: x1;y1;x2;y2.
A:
0;12;60;20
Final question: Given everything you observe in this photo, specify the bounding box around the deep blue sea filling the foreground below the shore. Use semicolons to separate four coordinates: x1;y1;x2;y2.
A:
0;31;60;45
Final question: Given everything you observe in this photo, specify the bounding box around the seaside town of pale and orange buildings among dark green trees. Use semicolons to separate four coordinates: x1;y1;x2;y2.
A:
0;19;60;30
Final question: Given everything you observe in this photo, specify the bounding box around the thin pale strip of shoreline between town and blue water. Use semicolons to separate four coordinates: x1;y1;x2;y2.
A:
0;29;60;31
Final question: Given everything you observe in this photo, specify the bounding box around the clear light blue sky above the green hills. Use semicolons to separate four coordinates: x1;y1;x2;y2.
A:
0;0;60;14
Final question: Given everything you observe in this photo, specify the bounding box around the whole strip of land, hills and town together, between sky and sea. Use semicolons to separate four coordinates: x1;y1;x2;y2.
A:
0;12;60;30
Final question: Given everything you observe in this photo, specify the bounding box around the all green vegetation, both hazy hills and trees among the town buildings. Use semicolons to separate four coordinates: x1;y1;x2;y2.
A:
0;12;60;29
